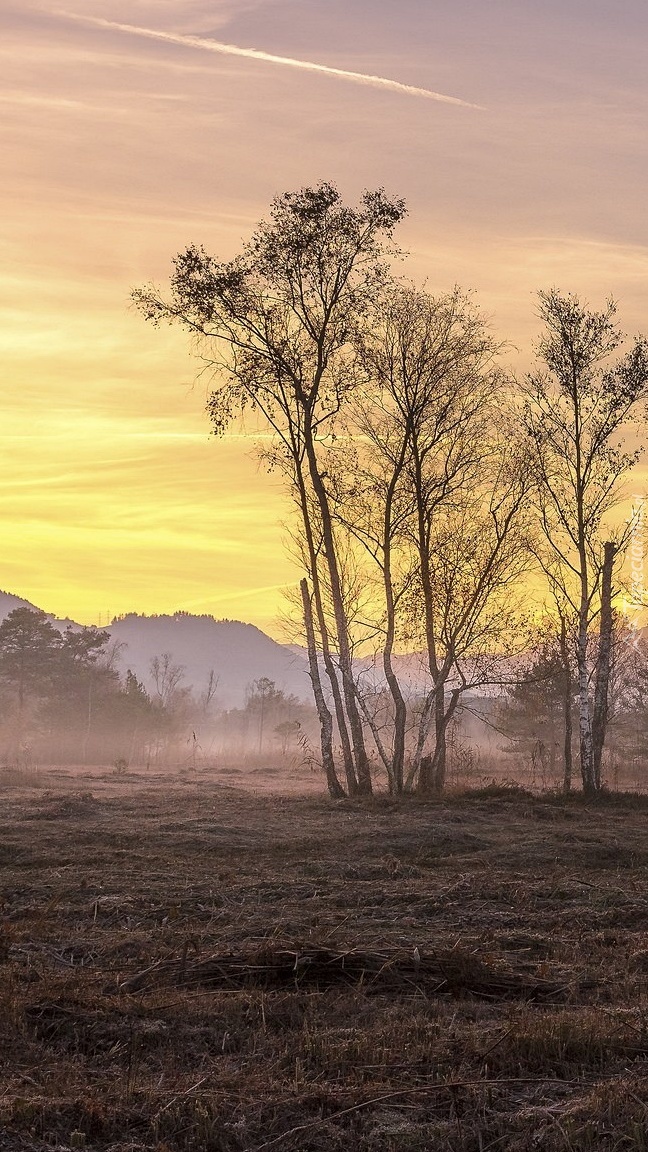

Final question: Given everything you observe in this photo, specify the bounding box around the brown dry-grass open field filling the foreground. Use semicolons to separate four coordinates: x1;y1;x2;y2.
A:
0;770;648;1152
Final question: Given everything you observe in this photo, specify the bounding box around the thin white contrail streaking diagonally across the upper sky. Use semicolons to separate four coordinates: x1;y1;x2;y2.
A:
59;12;482;109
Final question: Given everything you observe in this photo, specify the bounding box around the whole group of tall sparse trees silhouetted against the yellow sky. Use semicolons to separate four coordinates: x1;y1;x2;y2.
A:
134;182;648;796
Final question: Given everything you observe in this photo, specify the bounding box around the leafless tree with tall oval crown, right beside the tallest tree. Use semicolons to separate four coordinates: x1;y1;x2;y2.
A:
329;287;526;791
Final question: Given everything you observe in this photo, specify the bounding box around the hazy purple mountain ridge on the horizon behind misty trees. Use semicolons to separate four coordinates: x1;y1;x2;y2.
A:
0;592;310;708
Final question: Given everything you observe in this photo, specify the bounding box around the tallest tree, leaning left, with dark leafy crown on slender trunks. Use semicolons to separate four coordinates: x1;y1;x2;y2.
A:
135;183;405;793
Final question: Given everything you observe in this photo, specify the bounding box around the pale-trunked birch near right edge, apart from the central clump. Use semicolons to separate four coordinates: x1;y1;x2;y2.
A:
525;290;648;794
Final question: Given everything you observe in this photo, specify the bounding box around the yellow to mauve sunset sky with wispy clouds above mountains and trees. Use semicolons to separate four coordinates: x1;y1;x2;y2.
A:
0;0;648;636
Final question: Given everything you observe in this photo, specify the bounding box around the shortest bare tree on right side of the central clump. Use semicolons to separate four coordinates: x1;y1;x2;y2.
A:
414;440;529;793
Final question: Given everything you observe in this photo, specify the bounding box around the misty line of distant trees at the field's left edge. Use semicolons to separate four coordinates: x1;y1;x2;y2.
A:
0;607;312;771
